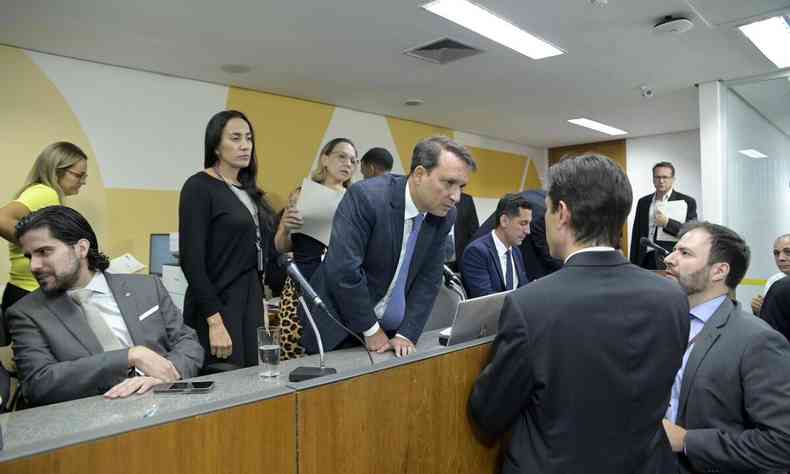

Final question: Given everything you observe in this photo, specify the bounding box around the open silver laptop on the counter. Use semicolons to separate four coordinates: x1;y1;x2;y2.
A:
439;290;512;346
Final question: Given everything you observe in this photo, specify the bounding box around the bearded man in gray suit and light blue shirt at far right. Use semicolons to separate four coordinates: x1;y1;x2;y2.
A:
664;222;790;473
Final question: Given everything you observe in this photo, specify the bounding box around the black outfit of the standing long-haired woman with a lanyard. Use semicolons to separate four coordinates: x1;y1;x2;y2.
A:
178;172;271;367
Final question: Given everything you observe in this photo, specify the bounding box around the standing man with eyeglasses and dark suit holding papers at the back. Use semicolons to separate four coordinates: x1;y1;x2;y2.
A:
629;161;697;270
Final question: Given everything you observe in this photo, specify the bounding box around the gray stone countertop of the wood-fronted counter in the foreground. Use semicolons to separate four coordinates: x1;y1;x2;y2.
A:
0;331;493;462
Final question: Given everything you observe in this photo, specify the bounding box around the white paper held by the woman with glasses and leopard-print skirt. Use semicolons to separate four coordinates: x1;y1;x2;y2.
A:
296;178;345;246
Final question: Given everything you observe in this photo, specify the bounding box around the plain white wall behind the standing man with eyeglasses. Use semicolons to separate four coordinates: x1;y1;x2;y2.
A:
625;130;702;250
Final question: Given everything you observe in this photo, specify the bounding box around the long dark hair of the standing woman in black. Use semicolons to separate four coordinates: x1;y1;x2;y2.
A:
203;110;274;232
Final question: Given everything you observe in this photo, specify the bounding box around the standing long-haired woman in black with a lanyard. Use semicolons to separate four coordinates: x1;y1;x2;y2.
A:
178;110;273;367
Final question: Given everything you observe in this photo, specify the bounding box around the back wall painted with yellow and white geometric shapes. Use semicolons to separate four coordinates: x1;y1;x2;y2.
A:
0;46;539;284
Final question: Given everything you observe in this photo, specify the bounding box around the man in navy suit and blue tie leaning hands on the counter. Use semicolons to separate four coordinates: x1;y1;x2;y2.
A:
302;137;476;356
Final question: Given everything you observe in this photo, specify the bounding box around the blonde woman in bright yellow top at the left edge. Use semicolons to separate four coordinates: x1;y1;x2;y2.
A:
0;142;88;312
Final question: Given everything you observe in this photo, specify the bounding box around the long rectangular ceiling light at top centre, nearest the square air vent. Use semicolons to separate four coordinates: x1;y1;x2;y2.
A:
422;0;565;59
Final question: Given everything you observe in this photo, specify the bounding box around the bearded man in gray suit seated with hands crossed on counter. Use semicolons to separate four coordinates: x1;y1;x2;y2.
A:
8;206;204;405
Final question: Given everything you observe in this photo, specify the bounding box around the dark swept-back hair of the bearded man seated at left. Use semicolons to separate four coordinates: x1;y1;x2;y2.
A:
16;206;110;272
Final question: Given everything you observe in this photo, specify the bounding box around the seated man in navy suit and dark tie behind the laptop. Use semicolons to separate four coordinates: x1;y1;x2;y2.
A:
461;194;532;298
